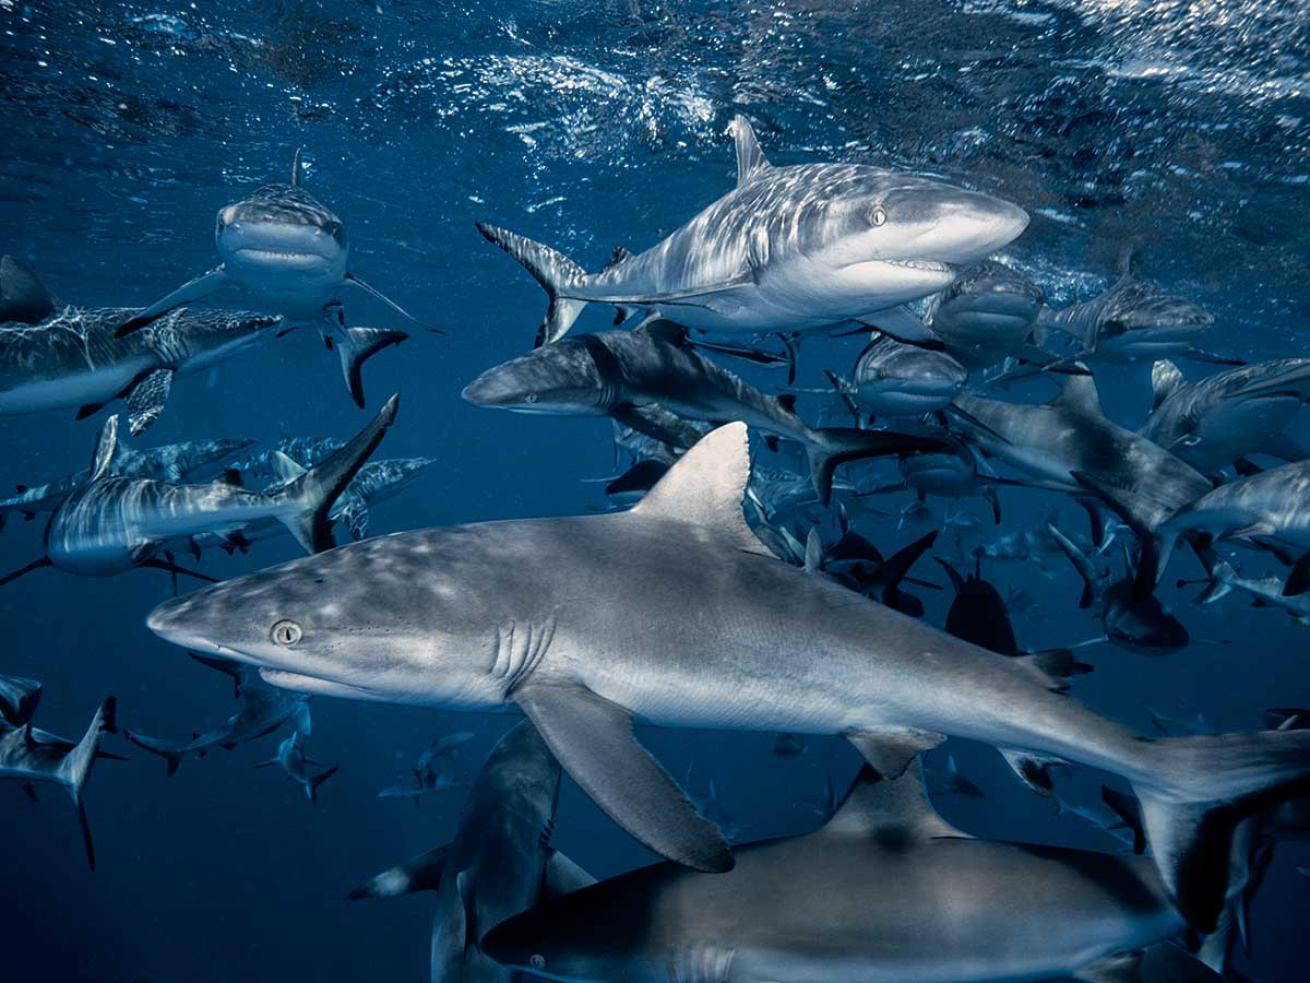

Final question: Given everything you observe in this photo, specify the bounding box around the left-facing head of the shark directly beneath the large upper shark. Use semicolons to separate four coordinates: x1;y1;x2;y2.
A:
464;336;614;415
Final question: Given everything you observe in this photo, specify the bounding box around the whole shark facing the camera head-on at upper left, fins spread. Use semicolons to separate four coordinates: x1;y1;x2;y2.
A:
114;151;427;406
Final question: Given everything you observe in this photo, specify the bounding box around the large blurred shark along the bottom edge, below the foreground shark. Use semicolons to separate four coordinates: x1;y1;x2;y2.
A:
483;760;1205;983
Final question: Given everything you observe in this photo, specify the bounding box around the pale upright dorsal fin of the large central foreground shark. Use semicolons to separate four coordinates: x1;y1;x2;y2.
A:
629;422;773;556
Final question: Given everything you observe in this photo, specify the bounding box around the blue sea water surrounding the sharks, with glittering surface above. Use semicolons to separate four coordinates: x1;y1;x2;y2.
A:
0;0;1310;983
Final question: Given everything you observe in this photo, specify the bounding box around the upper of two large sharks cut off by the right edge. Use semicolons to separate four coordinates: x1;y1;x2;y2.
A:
1137;358;1310;474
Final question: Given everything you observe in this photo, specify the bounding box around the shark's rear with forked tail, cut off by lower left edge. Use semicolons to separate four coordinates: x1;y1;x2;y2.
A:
0;697;117;870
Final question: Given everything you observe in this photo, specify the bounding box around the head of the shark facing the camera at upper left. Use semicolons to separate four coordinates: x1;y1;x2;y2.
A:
215;185;350;279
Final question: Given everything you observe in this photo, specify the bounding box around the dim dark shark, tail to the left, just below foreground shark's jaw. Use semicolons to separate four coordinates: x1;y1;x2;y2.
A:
123;657;312;775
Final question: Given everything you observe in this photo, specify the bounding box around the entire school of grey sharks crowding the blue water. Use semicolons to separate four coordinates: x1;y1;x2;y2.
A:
0;69;1310;983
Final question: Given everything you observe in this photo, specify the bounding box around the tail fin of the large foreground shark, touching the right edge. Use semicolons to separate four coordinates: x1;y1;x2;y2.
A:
1133;730;1310;933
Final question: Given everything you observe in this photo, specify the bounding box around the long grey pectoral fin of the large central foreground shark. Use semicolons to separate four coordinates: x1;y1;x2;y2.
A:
514;682;734;873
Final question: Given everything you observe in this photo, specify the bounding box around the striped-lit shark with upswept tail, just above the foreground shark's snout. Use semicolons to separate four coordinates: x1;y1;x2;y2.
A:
0;396;398;586
